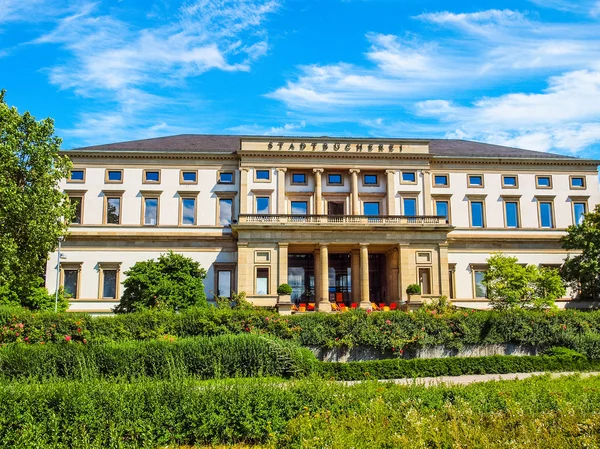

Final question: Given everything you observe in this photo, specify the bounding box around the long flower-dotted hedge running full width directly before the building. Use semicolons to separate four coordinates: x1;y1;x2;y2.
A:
0;308;600;358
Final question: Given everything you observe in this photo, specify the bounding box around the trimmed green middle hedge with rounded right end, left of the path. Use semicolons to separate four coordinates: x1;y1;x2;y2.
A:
0;334;317;380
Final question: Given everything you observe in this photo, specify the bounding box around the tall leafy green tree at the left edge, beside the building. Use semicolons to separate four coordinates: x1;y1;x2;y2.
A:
0;91;73;308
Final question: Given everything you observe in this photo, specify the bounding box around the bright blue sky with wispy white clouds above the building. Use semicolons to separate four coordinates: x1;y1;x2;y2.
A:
0;0;600;158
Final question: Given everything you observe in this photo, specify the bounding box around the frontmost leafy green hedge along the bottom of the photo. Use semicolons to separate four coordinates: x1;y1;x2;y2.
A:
0;377;600;449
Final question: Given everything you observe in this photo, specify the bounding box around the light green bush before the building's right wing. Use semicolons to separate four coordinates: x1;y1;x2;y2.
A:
483;253;566;310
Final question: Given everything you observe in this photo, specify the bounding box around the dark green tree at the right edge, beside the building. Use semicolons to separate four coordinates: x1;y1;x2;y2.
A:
561;206;600;300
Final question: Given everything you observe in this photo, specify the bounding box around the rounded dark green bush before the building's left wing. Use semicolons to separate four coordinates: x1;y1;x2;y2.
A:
115;251;208;313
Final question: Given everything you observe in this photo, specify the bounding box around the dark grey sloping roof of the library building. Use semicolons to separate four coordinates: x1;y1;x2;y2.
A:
65;134;578;160
